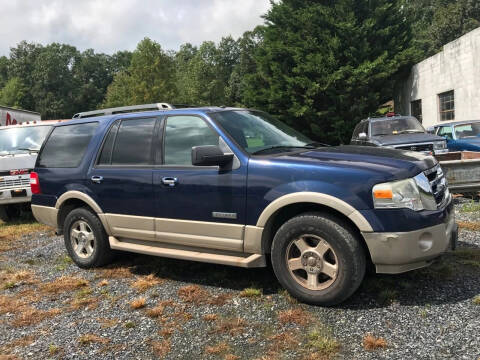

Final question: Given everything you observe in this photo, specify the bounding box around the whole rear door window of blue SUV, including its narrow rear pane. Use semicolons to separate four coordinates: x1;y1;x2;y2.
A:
98;118;156;166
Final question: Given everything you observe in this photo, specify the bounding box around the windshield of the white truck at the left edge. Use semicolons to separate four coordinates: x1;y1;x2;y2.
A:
0;126;52;155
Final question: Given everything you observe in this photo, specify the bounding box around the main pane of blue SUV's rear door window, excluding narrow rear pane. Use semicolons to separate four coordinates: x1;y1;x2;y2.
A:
111;118;155;165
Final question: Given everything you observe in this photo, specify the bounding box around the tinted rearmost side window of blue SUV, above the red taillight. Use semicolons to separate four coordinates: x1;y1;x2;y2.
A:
38;122;98;168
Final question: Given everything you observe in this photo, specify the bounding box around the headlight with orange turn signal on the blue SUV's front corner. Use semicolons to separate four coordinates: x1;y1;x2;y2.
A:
372;173;437;211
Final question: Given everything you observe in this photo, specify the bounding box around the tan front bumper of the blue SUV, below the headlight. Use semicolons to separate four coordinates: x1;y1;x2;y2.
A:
362;204;458;274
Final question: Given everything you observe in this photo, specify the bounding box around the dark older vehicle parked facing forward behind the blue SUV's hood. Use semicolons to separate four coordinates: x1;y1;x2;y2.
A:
350;114;448;154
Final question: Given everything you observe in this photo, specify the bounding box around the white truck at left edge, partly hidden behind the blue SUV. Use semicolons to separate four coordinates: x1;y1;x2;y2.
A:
0;121;52;221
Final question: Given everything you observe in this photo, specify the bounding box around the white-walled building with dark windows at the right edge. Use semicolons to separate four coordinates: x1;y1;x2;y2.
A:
394;28;480;127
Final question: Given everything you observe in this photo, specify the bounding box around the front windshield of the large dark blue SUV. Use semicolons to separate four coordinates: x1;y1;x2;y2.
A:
210;110;313;154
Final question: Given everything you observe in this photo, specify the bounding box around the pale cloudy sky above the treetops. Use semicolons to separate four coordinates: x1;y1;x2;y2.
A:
0;0;270;56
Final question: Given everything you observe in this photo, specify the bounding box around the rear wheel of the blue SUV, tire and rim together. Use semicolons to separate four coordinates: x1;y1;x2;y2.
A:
63;208;113;268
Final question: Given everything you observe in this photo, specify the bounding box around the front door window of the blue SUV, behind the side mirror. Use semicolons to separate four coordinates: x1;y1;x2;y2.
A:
164;116;218;165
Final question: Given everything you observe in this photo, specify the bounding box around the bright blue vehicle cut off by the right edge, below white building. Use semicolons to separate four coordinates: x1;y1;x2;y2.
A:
434;120;480;151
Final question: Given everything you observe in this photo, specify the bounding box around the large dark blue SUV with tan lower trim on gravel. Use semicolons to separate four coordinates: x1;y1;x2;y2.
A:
30;102;457;305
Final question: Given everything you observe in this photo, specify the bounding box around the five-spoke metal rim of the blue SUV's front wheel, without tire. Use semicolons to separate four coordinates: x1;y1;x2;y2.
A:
286;234;338;290
